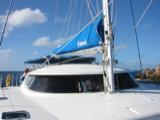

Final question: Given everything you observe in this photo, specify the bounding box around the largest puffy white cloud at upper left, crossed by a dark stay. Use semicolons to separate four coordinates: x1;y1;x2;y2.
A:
0;8;47;33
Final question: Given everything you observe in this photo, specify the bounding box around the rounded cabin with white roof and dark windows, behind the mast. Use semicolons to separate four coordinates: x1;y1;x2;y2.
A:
24;64;138;93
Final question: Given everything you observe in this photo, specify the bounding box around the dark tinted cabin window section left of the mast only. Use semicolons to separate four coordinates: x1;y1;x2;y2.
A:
26;75;103;93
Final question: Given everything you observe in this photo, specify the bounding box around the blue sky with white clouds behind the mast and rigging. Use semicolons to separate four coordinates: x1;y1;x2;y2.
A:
0;0;160;71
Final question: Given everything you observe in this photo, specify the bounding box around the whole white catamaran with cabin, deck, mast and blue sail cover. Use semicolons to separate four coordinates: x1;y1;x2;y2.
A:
0;0;160;120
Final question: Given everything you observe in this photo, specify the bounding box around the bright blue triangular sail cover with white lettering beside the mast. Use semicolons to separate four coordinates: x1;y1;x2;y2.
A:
53;15;103;54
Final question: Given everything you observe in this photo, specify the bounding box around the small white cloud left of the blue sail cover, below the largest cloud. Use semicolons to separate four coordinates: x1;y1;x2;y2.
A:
32;37;51;47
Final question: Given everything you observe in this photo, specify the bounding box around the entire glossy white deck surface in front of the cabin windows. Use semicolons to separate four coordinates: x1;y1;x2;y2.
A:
0;86;160;120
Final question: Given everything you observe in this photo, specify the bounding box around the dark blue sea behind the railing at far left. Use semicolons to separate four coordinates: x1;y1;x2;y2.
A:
0;71;23;87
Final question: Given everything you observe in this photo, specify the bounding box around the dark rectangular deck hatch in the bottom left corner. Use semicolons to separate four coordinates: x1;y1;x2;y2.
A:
2;110;31;120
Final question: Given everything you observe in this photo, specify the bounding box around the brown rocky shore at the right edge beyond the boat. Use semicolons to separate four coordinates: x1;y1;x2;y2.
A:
136;65;160;84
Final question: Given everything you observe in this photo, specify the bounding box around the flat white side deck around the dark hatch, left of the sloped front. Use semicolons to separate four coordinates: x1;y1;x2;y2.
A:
0;87;56;120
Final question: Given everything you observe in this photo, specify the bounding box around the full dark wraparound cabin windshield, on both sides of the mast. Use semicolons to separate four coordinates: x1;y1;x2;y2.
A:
26;73;137;93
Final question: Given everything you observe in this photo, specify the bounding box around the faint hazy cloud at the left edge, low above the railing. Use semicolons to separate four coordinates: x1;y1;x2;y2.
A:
0;49;12;61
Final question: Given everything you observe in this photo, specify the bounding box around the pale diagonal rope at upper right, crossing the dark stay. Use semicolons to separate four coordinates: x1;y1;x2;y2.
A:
119;0;153;45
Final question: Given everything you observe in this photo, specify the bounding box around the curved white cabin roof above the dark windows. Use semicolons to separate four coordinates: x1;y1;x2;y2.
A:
29;64;127;75
